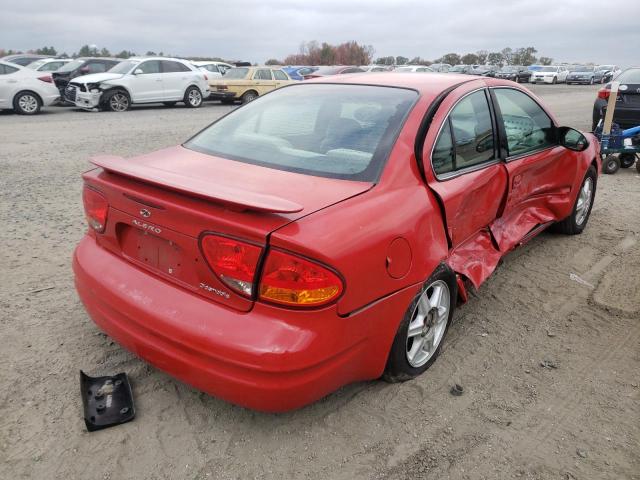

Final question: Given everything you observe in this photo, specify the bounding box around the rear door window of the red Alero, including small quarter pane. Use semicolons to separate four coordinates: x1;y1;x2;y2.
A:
431;90;495;175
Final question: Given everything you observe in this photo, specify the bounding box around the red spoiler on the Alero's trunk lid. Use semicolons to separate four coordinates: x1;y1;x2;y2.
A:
89;155;304;213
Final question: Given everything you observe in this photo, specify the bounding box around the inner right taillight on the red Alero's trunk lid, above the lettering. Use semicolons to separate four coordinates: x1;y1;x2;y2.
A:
200;235;262;297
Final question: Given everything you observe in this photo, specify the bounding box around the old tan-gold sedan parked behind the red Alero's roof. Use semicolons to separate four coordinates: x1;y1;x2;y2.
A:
208;67;294;103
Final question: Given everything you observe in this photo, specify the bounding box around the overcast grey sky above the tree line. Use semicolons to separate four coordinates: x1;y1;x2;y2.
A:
0;0;640;66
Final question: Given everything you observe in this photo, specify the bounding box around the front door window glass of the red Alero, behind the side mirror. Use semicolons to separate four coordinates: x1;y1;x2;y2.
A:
494;88;556;157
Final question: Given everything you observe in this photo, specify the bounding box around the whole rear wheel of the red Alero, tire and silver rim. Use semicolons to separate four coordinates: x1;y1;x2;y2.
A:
382;264;458;383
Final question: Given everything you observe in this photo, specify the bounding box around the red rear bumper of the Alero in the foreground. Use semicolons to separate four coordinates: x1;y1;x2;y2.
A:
73;236;419;412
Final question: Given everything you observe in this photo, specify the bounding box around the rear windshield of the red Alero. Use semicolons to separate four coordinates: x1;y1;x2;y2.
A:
184;84;418;182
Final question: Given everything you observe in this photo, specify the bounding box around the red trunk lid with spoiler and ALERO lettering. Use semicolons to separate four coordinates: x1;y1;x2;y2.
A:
83;147;373;311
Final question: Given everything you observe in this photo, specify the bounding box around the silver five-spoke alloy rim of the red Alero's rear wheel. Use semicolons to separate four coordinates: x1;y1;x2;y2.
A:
406;280;451;368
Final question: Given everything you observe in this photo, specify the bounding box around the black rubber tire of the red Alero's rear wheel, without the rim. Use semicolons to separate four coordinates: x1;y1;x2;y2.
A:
383;264;458;382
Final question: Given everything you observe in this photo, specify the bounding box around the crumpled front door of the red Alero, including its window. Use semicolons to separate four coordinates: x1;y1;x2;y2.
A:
491;87;579;252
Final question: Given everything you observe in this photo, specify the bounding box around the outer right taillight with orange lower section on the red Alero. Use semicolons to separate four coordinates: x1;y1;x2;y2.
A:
259;250;344;307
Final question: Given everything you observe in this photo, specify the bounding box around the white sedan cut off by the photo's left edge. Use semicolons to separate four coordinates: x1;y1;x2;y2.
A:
0;61;60;115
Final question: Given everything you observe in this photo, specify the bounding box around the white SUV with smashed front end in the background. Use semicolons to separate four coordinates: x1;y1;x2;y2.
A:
64;57;209;112
